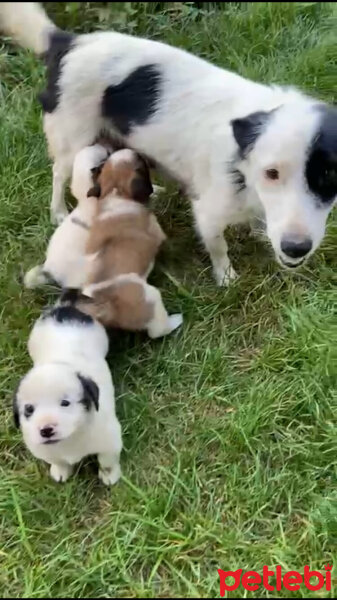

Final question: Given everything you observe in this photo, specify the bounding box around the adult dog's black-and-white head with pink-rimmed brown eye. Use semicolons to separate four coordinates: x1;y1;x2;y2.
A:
232;104;337;268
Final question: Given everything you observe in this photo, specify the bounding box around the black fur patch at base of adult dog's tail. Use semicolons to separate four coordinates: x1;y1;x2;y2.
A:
39;29;76;112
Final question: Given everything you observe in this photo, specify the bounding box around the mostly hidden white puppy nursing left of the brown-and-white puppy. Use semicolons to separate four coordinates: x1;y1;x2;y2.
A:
24;144;109;288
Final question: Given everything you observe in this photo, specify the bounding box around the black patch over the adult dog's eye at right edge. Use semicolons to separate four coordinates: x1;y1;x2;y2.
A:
305;106;337;204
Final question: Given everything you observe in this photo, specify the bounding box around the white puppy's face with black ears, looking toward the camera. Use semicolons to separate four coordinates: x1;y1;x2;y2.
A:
13;363;99;445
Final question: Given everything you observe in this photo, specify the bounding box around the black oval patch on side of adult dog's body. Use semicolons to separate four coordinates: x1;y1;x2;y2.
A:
102;64;161;135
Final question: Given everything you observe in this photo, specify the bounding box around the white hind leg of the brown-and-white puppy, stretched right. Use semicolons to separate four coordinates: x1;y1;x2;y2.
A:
145;284;183;339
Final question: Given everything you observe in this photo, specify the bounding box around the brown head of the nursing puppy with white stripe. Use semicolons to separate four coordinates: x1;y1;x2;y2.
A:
88;149;153;204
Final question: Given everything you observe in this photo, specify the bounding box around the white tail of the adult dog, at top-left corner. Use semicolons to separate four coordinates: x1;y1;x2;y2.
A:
0;2;57;54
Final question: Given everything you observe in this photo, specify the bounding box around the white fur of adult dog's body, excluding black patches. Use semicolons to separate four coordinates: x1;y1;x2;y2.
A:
0;2;331;284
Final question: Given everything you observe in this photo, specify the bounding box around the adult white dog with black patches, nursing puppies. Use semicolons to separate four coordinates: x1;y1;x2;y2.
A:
0;2;337;284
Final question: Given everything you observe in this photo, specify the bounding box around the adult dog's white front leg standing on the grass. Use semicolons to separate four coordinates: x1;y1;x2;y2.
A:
193;194;237;286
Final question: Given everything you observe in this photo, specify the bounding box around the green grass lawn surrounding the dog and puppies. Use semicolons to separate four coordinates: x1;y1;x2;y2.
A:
0;2;337;598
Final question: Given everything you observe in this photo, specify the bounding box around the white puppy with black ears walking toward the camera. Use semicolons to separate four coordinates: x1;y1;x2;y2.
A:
13;298;122;485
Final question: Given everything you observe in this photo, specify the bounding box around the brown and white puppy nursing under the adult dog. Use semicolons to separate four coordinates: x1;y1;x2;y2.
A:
79;149;182;338
